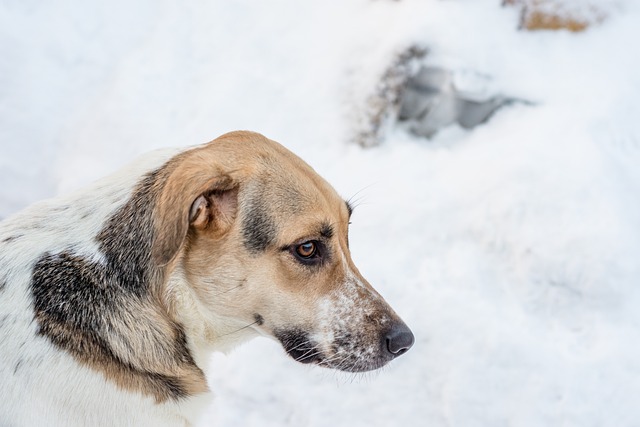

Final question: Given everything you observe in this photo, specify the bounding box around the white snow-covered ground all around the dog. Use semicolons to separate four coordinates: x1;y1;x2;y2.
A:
0;0;640;427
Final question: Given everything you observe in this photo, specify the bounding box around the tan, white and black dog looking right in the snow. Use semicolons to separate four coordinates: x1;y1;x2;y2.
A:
0;131;414;427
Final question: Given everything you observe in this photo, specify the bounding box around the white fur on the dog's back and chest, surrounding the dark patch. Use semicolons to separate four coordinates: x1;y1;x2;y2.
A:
0;150;218;427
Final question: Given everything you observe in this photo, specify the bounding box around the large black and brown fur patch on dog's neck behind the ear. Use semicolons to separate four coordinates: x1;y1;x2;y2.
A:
31;169;200;400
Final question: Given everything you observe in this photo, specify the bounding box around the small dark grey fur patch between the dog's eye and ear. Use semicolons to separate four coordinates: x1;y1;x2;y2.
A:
242;196;277;253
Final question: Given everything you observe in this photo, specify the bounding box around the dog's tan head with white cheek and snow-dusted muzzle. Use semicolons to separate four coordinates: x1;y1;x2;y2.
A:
153;132;414;372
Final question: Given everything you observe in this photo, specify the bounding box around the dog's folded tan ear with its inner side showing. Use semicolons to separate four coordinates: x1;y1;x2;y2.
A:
152;172;238;266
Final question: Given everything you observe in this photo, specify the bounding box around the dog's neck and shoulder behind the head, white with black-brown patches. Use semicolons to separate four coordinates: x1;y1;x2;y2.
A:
0;145;206;422
